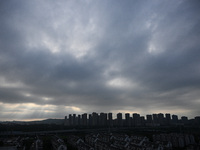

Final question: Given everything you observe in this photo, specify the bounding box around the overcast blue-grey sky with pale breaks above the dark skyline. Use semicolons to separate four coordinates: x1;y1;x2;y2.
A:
0;0;200;121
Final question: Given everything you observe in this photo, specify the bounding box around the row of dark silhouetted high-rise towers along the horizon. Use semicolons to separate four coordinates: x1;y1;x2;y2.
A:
65;112;200;127
